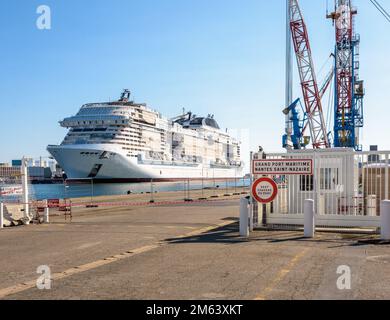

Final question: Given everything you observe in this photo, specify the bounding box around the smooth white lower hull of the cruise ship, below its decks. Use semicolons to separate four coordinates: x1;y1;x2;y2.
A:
48;144;243;182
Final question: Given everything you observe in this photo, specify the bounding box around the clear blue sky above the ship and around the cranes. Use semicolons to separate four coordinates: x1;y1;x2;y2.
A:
0;0;390;162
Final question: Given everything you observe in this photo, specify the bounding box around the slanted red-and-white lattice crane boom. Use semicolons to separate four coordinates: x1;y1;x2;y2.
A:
289;0;330;149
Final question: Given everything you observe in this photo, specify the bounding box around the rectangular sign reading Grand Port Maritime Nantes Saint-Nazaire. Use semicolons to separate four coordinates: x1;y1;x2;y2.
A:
252;159;313;175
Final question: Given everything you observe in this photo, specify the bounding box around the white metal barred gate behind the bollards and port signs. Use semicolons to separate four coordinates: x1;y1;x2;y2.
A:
252;149;390;228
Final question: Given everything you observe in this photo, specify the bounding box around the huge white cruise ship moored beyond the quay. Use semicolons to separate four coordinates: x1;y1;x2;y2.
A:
47;90;243;182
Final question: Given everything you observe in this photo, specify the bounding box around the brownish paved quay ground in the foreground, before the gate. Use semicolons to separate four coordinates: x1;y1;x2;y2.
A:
0;196;390;300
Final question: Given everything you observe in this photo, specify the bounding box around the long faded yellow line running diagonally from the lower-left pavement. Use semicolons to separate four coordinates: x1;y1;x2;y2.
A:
0;221;234;299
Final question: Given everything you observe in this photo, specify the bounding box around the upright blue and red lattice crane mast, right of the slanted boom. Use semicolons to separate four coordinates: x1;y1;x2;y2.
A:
327;0;364;151
